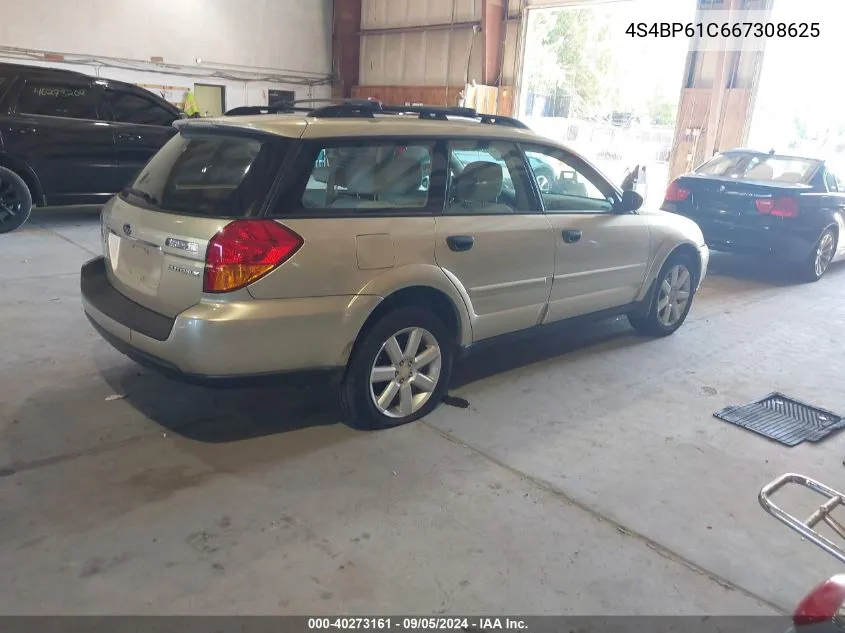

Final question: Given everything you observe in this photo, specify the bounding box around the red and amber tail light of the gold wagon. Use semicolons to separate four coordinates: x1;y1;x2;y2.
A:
202;220;303;293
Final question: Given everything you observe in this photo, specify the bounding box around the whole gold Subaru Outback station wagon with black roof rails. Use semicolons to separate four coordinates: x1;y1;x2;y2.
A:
81;102;708;428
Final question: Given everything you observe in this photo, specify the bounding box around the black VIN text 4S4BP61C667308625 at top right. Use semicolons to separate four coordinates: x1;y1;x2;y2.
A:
625;22;821;38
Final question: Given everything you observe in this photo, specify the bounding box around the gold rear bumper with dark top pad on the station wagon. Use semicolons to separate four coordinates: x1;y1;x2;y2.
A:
80;257;381;383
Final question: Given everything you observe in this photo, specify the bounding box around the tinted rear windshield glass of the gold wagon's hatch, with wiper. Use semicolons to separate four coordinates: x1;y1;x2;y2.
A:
121;131;290;218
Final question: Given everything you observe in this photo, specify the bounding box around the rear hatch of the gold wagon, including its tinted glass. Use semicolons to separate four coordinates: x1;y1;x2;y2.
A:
102;122;302;317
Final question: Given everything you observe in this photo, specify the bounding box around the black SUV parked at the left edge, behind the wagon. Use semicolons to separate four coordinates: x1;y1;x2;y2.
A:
0;64;182;233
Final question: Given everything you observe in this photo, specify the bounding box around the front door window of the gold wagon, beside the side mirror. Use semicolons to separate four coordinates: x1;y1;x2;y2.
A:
525;151;613;213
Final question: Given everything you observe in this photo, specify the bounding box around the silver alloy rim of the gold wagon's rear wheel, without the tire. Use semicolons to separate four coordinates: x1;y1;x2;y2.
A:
370;327;442;418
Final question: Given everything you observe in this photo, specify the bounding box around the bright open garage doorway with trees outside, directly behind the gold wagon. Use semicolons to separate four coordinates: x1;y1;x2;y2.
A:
518;0;695;205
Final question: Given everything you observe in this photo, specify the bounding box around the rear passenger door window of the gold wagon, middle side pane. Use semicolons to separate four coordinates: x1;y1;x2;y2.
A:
446;140;531;215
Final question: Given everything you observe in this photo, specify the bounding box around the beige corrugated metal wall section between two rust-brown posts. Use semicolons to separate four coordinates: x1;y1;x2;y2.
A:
360;0;482;86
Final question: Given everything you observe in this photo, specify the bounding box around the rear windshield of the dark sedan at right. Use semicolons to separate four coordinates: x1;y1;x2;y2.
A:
695;153;819;184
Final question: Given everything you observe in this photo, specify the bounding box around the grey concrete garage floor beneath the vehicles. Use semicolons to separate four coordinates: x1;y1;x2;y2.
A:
0;211;845;615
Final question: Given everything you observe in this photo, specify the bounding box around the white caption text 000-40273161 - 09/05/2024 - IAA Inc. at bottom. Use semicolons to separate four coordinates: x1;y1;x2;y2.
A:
308;616;527;631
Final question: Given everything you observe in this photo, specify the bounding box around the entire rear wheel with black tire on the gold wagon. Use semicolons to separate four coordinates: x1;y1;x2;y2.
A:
340;306;453;430
